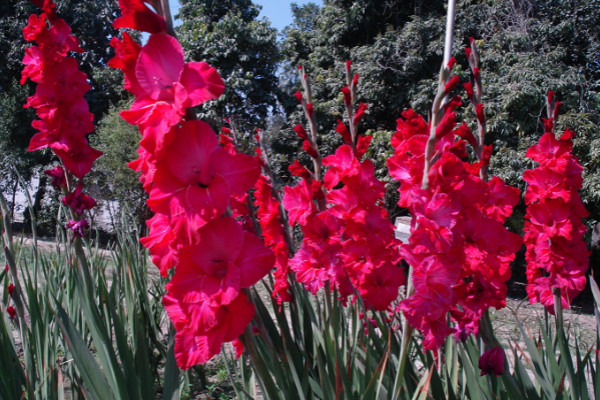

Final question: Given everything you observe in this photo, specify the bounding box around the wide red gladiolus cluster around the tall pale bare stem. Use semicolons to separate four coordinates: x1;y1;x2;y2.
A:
388;99;521;349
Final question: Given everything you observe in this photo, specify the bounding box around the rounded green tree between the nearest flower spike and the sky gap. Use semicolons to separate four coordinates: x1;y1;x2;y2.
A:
177;0;279;131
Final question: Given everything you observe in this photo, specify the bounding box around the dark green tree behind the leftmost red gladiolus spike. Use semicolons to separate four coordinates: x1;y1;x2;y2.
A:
0;0;125;228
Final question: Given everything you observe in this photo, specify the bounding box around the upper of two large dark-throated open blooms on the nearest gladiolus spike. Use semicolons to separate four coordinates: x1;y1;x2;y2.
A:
148;120;260;236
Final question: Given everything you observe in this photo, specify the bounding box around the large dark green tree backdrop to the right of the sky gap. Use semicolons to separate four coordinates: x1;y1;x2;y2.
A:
282;0;600;228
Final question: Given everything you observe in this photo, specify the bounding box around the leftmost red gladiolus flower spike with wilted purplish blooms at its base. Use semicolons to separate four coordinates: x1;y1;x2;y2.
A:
21;0;102;231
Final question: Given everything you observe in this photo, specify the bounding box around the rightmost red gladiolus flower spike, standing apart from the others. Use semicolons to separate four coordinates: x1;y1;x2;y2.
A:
523;92;589;313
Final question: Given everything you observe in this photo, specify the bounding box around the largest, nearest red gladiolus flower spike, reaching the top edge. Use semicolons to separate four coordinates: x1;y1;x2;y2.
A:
109;0;274;369
